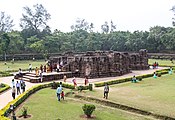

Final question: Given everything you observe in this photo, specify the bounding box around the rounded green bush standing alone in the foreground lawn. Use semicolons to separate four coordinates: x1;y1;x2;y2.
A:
82;104;95;118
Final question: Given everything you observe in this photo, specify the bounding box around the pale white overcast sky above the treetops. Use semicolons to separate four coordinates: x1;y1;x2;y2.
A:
0;0;175;32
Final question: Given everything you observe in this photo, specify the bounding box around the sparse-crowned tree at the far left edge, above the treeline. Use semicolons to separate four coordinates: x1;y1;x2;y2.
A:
0;12;14;33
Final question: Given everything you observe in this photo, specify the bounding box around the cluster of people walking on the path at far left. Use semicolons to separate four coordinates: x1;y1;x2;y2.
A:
12;79;26;99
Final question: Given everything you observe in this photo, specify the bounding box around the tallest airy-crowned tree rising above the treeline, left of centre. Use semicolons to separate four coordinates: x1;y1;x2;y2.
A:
20;4;51;32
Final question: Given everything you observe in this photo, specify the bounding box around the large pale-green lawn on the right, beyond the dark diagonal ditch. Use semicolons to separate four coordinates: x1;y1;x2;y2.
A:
82;73;175;118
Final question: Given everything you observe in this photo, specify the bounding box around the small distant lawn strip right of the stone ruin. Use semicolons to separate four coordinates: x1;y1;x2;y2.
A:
148;59;175;66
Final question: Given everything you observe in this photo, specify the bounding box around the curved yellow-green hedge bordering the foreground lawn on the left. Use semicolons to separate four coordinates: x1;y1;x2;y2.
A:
0;83;74;120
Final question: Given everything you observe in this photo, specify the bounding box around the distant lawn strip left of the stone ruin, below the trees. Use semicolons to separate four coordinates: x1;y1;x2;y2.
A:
0;60;45;71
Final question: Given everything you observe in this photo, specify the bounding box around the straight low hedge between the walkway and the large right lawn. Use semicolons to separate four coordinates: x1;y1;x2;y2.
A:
95;69;169;87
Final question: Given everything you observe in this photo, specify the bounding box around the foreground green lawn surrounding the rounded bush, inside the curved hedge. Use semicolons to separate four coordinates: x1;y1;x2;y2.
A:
16;88;153;120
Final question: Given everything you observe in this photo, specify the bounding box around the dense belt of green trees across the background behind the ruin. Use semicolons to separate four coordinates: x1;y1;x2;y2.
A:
0;4;175;59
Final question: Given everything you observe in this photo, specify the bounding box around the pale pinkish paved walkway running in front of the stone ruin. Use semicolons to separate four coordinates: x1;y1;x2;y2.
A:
0;67;165;109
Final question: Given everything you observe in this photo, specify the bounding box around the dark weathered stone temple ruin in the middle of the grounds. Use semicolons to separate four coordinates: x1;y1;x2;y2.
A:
50;49;149;78
